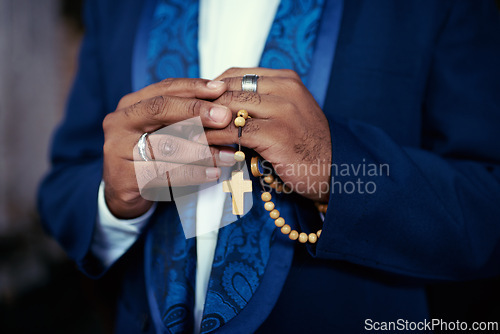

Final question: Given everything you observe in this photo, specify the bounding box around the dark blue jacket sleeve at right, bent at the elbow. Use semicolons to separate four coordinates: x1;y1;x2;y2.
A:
311;1;500;280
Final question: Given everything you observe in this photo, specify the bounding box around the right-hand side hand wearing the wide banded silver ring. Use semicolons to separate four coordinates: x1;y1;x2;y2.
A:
206;68;332;202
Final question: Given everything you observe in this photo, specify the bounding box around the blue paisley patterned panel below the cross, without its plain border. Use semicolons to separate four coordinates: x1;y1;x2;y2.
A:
201;187;295;333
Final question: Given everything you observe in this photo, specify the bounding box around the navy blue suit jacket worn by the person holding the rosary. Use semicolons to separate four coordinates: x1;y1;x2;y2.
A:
39;0;500;333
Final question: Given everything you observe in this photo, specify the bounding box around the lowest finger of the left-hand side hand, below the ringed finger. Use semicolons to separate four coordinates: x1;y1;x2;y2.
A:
133;161;221;193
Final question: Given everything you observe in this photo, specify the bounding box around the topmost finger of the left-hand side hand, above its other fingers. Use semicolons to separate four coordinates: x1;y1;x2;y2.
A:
117;78;227;109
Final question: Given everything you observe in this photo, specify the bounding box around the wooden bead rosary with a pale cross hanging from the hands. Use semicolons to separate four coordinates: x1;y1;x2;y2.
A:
222;110;328;244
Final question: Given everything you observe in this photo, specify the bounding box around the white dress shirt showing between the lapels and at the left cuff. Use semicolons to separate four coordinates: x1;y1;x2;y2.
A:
91;0;280;332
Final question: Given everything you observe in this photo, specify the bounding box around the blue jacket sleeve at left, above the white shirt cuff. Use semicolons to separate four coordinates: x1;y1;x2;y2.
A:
38;1;106;274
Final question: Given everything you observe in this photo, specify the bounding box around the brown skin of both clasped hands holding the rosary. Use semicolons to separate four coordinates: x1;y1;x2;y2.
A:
103;68;331;219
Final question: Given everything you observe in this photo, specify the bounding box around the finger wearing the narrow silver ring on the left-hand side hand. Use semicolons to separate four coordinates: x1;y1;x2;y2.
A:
143;134;236;167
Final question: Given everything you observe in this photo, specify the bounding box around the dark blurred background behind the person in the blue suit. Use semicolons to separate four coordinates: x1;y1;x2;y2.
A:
0;0;500;334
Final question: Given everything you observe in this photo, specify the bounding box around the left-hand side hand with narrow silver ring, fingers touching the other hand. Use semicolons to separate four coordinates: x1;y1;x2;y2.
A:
103;79;235;219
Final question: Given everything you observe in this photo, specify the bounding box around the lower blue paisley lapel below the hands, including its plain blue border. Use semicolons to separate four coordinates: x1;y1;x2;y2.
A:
201;190;298;333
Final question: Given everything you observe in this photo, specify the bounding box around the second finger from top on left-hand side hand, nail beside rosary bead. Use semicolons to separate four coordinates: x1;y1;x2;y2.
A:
119;96;232;132
